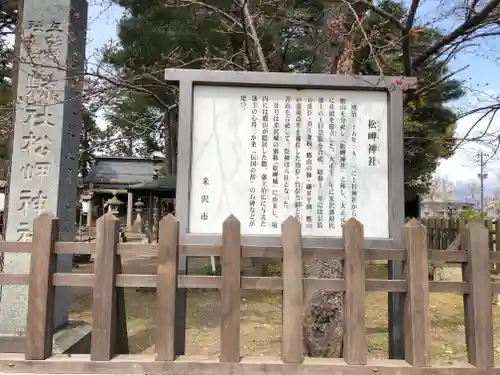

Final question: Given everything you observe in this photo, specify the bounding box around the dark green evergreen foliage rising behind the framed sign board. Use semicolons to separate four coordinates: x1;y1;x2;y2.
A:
105;0;463;198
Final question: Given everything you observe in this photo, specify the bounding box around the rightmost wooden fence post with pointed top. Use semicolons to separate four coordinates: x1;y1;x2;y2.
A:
462;221;494;369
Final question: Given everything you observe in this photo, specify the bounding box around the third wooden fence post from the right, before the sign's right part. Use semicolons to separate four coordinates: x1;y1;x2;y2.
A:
342;219;367;365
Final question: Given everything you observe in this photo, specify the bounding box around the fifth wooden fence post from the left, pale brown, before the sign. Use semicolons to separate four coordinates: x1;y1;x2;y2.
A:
281;216;304;363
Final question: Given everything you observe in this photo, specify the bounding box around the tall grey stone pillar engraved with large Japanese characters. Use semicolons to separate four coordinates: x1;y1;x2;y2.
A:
0;0;87;335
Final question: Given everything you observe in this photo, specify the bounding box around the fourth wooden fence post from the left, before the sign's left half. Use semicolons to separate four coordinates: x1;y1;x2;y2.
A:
220;215;241;363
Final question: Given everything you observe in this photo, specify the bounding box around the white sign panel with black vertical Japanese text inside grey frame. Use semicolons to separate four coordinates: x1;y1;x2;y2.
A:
188;86;389;238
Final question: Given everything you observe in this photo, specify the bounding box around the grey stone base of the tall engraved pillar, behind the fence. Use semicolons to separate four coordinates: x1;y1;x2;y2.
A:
0;321;92;354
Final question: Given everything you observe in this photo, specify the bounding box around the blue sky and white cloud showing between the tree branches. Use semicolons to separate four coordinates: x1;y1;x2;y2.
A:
83;0;500;185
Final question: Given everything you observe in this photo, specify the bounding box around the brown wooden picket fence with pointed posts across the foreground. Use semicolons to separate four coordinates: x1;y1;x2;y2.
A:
0;214;500;375
